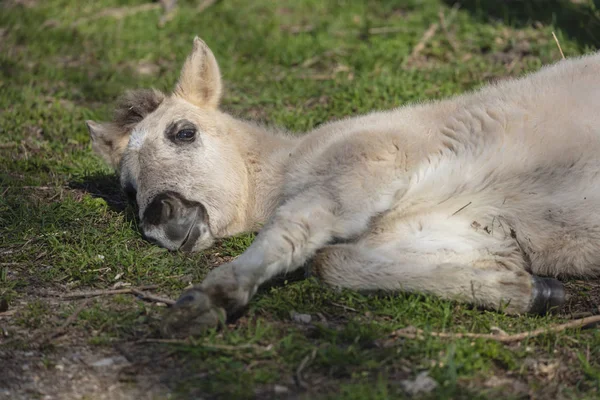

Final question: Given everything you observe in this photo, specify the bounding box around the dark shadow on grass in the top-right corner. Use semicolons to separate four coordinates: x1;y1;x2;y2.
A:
443;0;600;48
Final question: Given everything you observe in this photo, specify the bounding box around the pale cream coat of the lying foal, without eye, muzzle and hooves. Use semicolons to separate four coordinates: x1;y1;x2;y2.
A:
91;38;600;324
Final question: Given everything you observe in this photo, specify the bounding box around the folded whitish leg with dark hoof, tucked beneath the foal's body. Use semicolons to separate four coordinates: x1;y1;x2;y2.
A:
312;216;565;314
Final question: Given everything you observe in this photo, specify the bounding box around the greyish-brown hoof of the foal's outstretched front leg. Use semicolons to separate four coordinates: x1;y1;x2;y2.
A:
161;288;227;338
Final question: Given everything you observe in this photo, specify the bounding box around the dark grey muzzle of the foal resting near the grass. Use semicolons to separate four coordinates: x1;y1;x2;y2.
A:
140;191;211;252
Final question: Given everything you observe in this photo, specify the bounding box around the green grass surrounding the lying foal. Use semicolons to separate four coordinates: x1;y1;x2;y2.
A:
0;0;600;399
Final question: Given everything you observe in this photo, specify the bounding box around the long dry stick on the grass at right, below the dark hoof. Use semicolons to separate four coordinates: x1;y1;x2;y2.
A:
390;315;600;343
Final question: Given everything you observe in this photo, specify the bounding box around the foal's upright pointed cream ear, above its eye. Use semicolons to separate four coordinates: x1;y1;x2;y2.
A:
175;36;222;109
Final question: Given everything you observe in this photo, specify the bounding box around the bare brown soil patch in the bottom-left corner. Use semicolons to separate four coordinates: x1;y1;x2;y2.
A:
0;291;178;400
